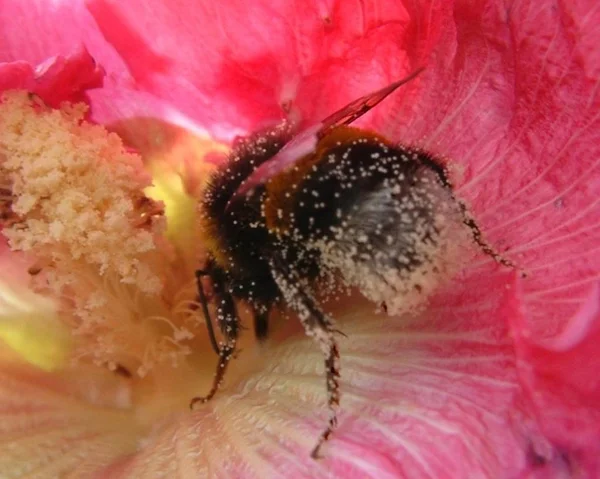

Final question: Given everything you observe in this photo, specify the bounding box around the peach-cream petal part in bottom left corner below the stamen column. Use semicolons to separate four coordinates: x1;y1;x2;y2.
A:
0;358;140;479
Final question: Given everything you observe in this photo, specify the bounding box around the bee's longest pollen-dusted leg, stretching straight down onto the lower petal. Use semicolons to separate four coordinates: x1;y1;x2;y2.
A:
271;262;340;459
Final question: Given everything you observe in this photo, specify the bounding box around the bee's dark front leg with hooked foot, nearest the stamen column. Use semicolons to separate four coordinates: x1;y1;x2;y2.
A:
190;284;239;408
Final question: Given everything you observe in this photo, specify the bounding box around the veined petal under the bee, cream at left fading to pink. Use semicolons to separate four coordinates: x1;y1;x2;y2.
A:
98;276;528;478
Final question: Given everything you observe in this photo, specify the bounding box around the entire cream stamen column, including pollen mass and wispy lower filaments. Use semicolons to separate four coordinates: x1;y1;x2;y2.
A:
0;92;199;374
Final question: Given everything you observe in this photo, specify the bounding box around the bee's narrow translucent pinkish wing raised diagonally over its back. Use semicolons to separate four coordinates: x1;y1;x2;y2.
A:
232;67;424;200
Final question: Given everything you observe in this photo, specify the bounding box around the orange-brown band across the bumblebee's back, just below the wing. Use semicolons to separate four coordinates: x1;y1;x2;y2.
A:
263;126;393;235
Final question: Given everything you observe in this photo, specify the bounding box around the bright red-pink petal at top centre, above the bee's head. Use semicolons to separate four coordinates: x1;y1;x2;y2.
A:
88;0;422;137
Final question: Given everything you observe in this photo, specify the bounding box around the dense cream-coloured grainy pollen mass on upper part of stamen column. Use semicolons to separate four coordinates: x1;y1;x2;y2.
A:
0;93;163;293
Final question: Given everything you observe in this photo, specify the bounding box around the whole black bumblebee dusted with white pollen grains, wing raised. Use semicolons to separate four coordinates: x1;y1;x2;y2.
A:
191;71;509;458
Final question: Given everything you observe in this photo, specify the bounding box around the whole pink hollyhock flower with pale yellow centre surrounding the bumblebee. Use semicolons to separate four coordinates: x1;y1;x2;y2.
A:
0;0;600;478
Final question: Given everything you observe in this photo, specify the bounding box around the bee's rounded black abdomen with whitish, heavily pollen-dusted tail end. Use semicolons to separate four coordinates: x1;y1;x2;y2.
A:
288;130;457;312
